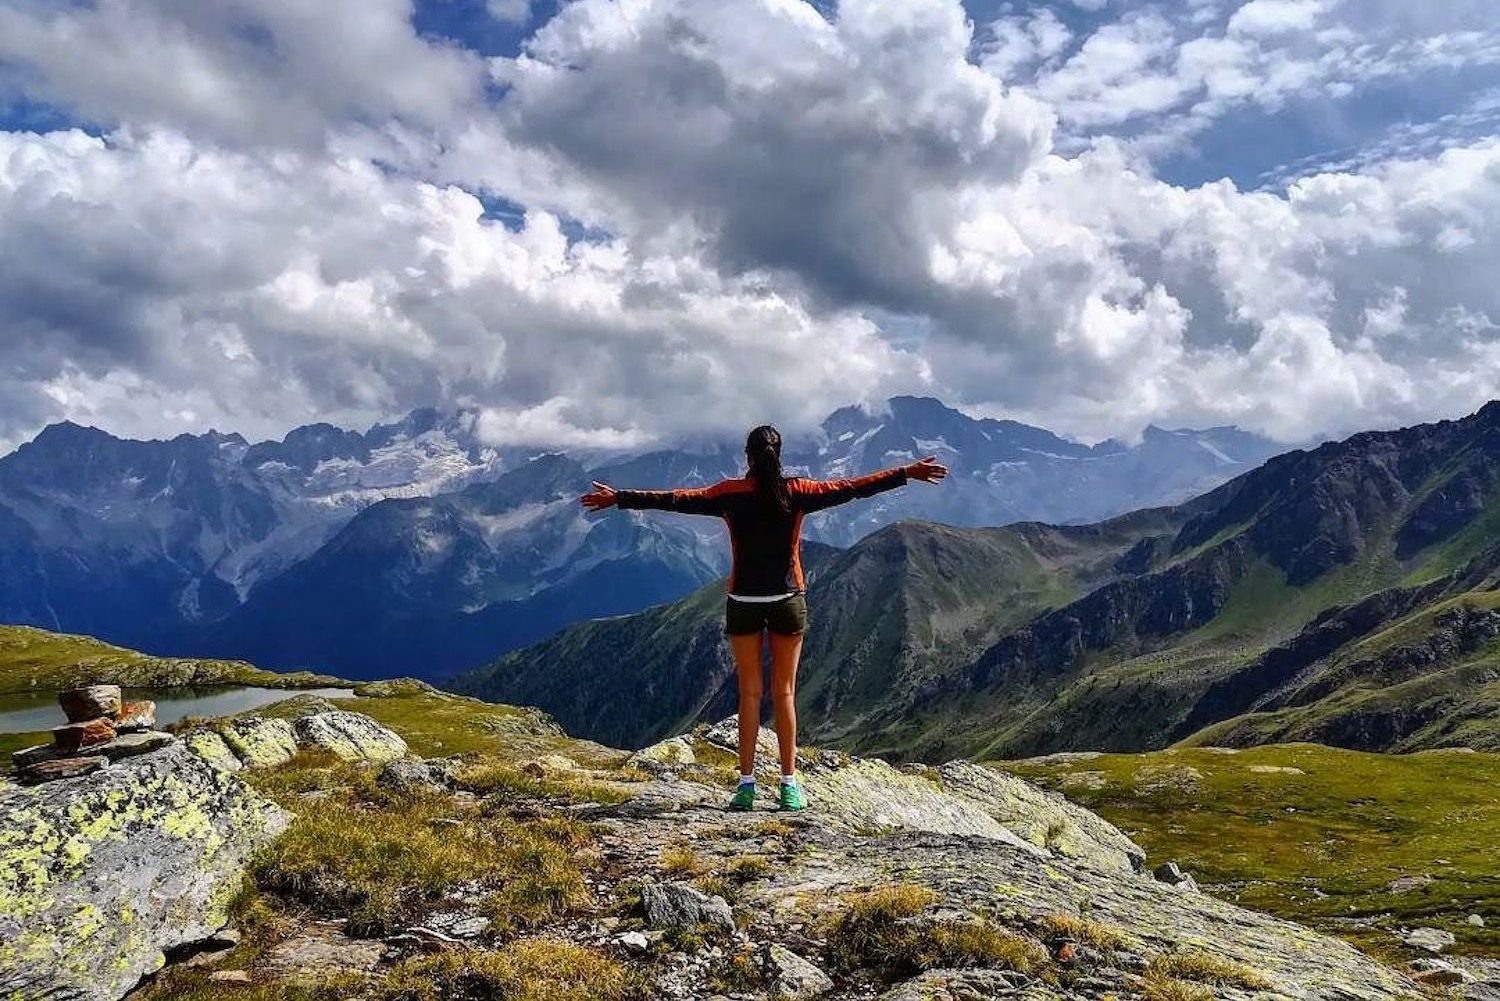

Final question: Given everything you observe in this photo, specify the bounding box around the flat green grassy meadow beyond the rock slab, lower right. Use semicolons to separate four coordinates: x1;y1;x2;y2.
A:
993;744;1500;957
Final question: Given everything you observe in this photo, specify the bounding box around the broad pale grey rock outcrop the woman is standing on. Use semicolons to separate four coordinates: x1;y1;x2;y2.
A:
587;725;1419;1001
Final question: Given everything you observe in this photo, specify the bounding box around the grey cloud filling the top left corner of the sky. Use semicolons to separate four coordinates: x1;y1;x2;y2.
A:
0;0;483;147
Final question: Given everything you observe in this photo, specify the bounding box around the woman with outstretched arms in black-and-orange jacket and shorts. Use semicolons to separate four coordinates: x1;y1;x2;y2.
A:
582;425;948;810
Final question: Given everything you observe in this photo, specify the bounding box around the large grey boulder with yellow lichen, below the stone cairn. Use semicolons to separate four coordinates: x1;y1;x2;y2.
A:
0;743;288;1001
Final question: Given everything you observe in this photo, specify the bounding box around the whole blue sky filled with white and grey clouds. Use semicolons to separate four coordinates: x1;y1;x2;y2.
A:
0;0;1500;449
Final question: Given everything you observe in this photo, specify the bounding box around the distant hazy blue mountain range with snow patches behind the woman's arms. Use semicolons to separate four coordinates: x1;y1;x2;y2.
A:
0;398;1280;678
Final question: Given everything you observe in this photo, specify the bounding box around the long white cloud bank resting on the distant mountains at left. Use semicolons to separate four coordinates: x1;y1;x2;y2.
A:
0;132;923;440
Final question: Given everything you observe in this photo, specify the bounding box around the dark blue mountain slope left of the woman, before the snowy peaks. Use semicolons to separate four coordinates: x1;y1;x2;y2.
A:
191;456;722;678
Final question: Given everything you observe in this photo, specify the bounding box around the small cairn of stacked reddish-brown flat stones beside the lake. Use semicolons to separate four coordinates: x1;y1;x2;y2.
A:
11;684;177;785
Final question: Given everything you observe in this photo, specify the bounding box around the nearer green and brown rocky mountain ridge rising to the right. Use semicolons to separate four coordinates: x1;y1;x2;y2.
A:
452;402;1500;759
